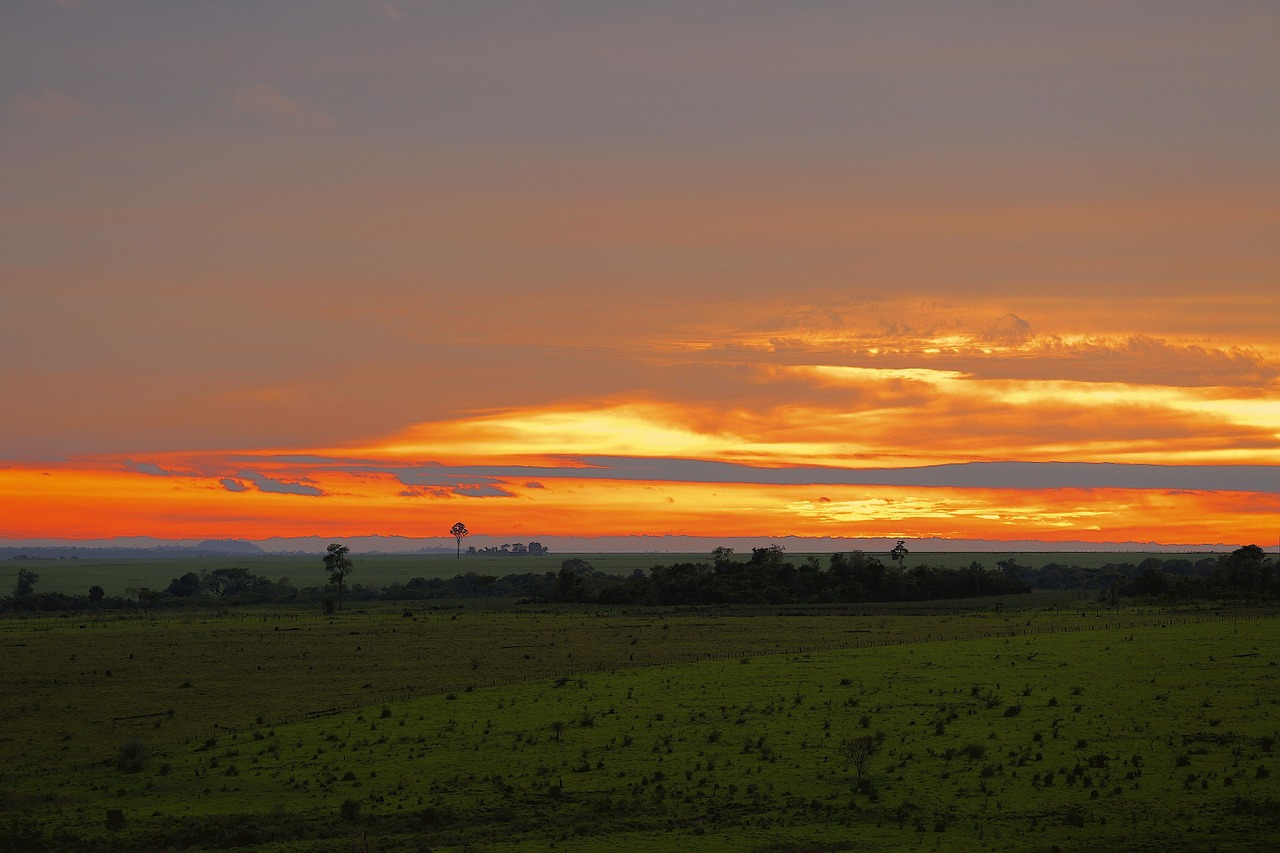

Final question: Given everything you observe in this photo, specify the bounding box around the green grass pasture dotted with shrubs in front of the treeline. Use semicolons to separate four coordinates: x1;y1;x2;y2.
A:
0;602;1280;850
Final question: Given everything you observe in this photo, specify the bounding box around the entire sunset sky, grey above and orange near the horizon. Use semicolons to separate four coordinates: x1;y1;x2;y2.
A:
0;0;1280;546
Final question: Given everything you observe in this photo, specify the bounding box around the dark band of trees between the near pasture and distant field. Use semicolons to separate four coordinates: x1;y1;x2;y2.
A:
0;546;1280;612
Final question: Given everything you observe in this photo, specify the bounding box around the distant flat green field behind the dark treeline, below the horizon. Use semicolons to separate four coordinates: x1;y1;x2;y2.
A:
0;551;1211;596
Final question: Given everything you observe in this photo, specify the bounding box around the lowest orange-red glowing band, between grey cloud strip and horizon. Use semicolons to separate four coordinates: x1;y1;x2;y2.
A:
0;458;1280;544
